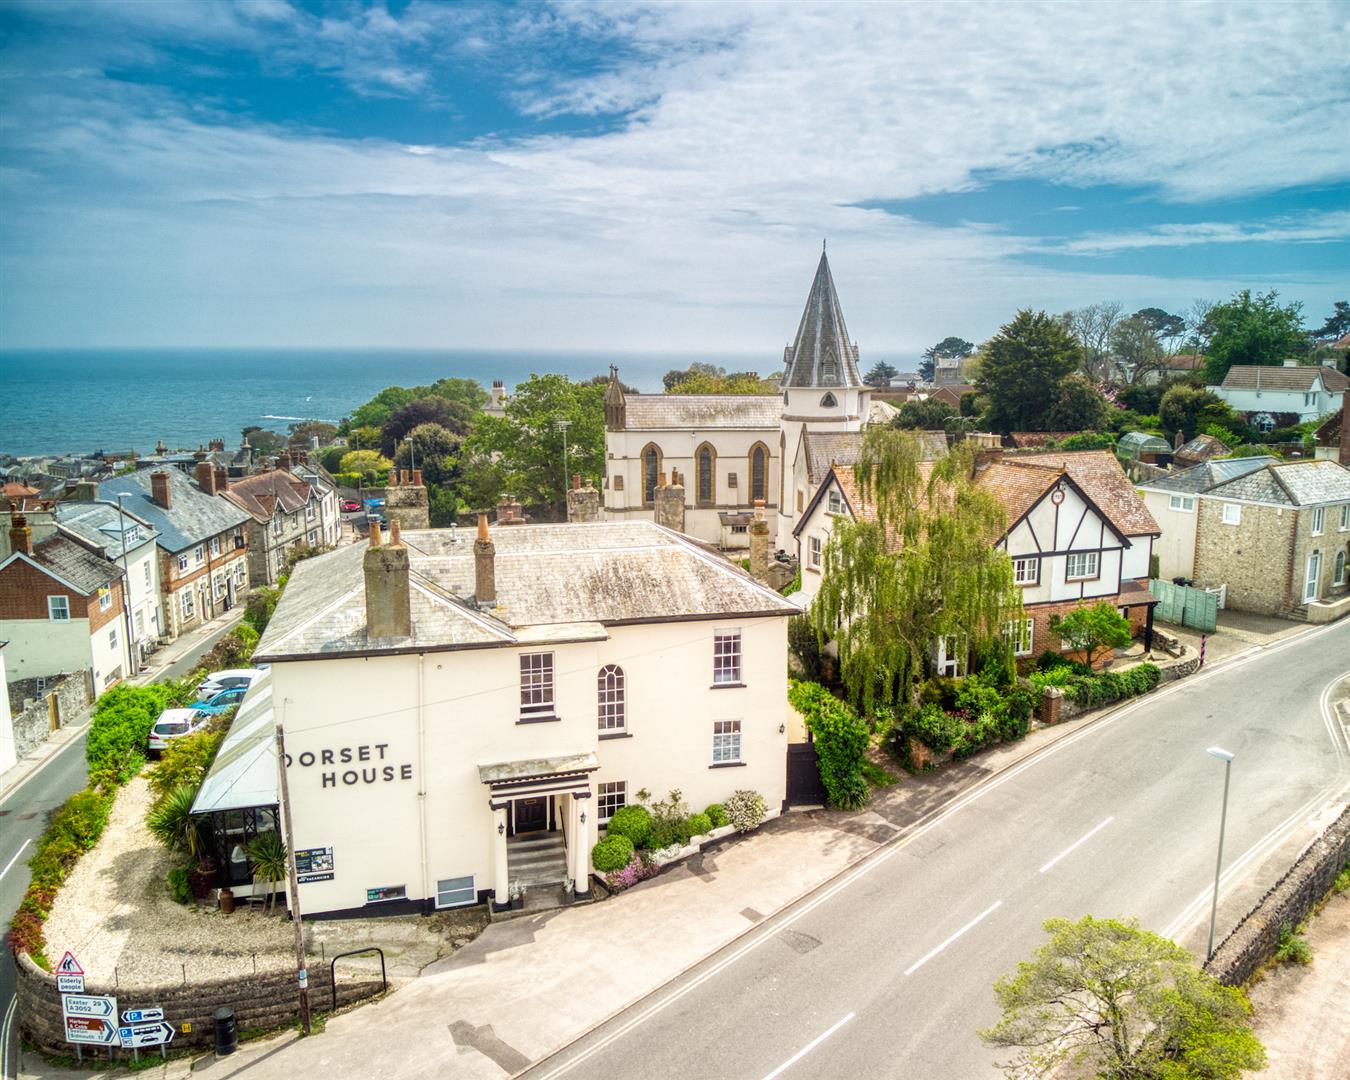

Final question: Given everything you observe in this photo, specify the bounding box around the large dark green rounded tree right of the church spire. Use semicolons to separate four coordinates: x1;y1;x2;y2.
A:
976;311;1083;432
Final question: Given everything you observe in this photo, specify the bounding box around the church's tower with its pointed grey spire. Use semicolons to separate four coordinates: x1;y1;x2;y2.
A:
778;250;872;548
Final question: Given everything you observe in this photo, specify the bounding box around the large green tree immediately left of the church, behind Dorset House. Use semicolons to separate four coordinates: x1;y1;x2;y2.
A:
464;375;605;508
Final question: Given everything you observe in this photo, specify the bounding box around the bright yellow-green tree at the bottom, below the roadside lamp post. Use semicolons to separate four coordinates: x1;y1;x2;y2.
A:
980;915;1265;1080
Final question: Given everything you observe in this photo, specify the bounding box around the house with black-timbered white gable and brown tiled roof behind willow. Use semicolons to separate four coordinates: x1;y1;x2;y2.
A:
797;451;1158;675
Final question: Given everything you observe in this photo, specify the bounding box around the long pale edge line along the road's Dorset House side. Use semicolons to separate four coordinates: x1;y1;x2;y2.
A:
514;622;1345;1080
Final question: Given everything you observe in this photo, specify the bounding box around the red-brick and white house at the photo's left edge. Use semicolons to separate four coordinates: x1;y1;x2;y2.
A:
0;512;130;694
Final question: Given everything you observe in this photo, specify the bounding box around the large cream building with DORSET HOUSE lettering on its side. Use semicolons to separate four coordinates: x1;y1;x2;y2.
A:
233;521;797;914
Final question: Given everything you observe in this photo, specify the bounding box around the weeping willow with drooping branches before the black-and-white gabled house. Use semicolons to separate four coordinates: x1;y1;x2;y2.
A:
810;428;1022;713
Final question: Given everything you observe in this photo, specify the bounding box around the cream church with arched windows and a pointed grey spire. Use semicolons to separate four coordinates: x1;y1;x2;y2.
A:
603;251;895;554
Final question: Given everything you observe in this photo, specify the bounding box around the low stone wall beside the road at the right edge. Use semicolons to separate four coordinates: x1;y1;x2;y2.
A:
1204;806;1350;986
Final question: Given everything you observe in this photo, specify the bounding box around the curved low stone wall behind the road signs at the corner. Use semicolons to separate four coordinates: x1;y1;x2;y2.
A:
16;953;381;1057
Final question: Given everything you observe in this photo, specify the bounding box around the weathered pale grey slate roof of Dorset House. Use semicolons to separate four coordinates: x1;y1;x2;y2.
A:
254;521;798;663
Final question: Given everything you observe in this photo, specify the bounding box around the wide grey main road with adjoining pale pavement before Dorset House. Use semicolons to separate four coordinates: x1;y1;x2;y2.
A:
18;612;1350;1080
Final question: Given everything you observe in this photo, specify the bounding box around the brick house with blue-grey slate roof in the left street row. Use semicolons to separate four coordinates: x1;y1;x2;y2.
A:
99;462;250;639
